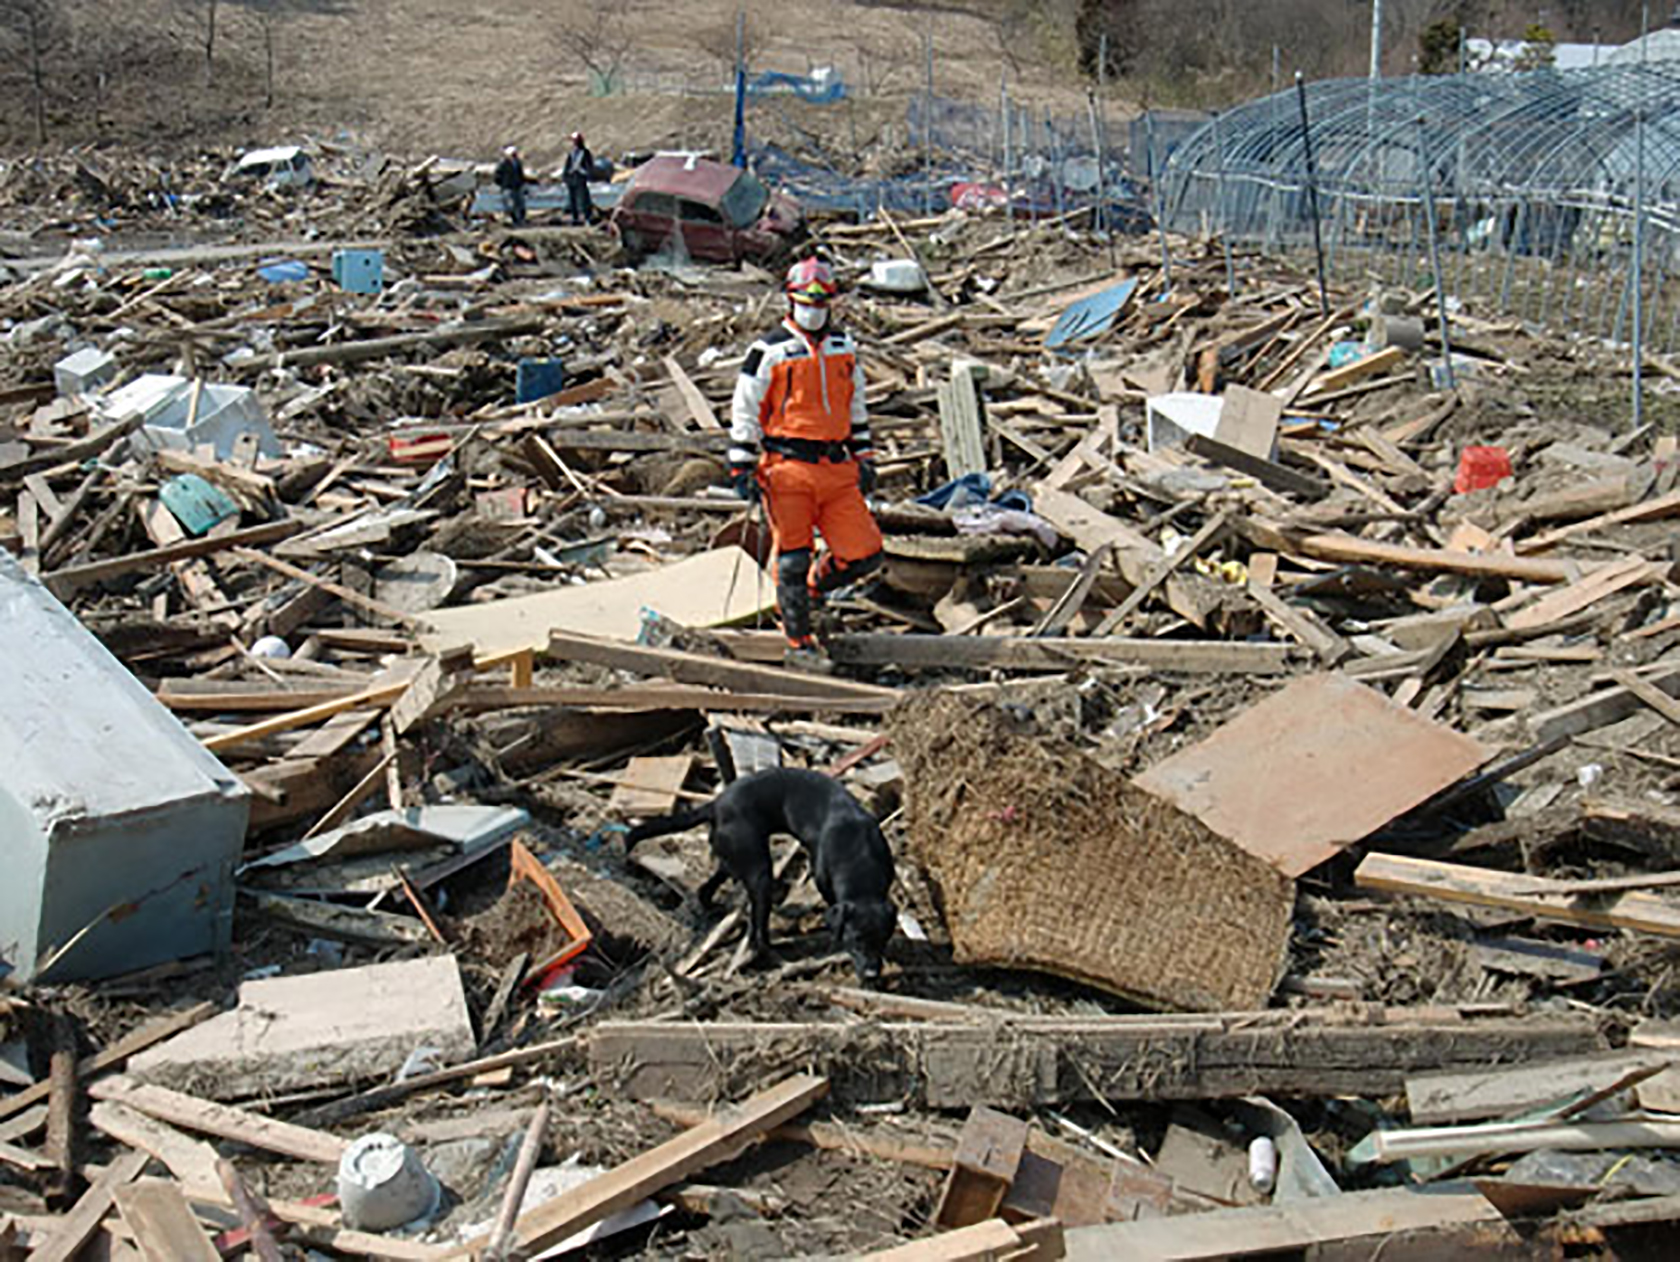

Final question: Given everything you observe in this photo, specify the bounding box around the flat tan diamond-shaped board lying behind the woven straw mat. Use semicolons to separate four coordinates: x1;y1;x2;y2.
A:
1136;674;1488;877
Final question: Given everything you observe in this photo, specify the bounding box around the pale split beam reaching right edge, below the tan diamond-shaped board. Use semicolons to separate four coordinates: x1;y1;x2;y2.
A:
1354;854;1680;938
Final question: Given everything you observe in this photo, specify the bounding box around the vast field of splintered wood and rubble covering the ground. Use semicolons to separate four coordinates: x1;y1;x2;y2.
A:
0;158;1680;1259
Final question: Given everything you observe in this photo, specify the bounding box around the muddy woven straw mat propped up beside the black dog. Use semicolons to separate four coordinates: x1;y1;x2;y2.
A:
889;696;1294;1010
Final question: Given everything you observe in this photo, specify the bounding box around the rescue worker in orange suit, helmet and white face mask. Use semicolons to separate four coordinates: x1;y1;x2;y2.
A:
729;259;882;669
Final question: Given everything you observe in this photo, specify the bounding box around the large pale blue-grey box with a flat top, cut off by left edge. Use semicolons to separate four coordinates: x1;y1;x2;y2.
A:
0;551;250;981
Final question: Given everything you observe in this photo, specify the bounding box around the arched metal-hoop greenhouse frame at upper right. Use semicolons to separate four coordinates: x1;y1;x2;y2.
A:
1163;62;1680;364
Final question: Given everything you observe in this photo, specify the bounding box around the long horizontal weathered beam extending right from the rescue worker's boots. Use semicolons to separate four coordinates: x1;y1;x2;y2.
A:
827;634;1292;676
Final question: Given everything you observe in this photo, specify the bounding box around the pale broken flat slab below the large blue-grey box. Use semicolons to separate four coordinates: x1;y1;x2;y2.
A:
129;956;474;1099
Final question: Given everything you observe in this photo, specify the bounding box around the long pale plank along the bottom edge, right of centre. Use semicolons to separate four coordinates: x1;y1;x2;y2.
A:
1063;1183;1502;1262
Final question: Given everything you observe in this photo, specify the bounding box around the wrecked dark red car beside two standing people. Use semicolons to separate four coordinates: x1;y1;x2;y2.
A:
608;155;805;262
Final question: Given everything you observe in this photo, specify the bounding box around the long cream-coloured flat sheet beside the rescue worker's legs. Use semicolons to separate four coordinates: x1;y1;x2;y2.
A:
422;548;776;654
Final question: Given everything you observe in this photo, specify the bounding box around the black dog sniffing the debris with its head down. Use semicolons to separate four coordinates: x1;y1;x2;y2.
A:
625;768;899;981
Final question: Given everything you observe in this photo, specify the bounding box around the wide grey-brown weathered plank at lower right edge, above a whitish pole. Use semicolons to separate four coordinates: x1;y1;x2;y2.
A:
1406;1049;1675;1126
